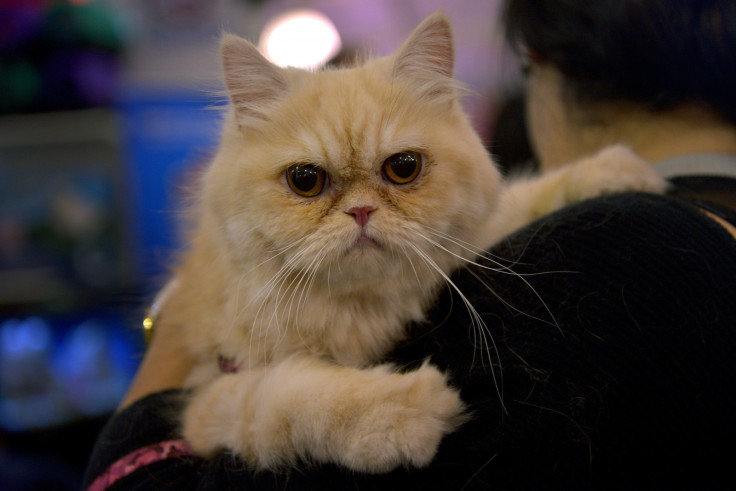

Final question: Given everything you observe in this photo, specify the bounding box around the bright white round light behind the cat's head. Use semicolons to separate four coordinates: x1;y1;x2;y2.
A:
258;10;342;70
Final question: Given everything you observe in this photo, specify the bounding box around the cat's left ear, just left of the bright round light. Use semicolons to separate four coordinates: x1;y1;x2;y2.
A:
220;34;287;124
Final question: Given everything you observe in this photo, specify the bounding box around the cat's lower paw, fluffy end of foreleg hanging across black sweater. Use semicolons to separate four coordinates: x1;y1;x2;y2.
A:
340;363;464;472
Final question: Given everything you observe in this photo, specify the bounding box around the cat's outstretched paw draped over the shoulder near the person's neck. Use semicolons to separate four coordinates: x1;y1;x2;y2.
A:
567;145;668;202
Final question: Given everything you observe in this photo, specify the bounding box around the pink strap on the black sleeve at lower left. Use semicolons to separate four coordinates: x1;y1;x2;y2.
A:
87;440;194;491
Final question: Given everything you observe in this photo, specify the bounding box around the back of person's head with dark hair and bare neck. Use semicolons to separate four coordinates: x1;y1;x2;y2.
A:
504;0;736;186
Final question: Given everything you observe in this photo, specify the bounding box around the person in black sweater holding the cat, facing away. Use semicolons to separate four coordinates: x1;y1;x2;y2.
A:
85;0;736;490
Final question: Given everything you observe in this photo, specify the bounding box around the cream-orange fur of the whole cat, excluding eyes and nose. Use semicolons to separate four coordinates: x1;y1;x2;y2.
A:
163;14;664;472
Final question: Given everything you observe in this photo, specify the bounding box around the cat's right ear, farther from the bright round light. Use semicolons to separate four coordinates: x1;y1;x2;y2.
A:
393;12;456;100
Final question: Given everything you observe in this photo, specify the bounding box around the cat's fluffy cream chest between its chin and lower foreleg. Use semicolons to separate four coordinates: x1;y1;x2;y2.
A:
209;260;439;367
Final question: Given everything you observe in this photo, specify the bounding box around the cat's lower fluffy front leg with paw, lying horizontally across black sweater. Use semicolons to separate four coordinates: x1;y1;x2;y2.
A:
183;357;463;472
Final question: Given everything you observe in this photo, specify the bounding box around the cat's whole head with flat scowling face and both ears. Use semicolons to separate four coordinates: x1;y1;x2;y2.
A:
205;18;500;298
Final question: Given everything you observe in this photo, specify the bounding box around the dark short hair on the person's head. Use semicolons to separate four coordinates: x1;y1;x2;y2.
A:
503;0;736;124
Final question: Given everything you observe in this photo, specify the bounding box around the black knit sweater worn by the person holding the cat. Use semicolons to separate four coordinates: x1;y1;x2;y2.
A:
82;194;736;490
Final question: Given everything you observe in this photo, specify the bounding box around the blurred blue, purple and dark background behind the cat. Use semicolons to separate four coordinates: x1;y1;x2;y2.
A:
0;0;529;490
